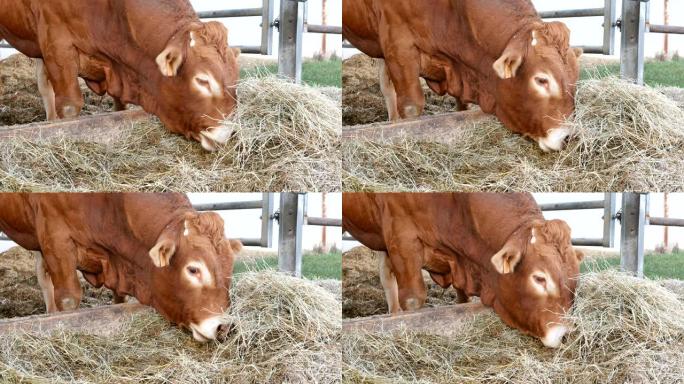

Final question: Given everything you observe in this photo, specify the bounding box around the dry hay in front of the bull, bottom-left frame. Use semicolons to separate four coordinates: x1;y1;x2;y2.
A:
0;272;341;384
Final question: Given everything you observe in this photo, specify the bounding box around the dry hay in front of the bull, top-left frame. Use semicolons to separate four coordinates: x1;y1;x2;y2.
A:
0;76;341;192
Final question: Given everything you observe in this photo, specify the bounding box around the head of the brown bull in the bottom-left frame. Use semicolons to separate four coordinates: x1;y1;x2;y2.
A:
149;212;242;342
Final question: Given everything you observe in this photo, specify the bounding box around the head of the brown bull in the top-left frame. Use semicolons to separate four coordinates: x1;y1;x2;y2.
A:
156;21;240;151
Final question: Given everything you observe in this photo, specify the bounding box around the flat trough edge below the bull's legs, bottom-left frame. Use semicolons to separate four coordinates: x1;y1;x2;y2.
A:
0;303;153;335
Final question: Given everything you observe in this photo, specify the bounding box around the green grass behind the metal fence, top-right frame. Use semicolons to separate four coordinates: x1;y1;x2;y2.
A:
580;60;684;88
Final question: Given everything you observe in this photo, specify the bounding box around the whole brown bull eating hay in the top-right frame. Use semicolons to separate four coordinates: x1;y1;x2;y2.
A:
342;0;581;151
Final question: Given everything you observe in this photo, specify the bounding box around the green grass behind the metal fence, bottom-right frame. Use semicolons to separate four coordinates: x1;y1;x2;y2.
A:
581;253;684;280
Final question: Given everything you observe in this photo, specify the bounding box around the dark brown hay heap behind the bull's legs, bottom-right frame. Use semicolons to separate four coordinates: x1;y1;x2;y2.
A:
342;246;468;318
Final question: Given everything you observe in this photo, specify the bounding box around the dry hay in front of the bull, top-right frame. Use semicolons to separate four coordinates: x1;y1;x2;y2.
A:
342;78;684;192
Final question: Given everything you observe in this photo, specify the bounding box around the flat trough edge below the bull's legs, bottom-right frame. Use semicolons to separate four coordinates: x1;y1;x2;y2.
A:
342;303;491;335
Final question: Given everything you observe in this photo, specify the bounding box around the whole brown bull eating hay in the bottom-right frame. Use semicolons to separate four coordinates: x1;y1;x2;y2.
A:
342;193;583;347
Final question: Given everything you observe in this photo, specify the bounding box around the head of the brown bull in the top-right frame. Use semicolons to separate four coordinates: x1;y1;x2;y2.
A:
493;22;582;152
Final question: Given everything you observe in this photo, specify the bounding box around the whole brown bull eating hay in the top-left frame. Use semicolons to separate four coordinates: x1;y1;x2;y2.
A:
0;0;239;150
